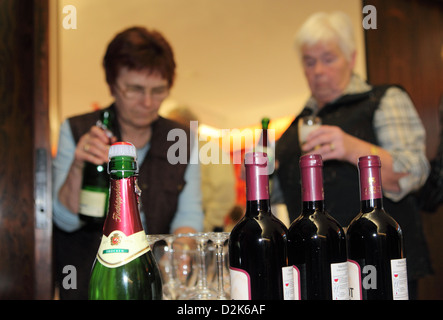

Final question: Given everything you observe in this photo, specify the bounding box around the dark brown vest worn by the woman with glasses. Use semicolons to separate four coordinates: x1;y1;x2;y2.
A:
69;105;189;234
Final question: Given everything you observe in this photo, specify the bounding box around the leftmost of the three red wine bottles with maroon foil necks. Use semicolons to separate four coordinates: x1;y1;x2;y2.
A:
229;152;293;300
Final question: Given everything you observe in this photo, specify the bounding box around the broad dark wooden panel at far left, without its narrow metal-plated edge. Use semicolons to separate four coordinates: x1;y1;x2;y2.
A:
0;0;34;299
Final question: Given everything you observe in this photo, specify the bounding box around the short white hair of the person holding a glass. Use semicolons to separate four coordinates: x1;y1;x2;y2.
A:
295;11;355;61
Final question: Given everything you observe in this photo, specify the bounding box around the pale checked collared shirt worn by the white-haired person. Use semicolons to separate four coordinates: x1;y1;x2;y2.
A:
306;74;430;201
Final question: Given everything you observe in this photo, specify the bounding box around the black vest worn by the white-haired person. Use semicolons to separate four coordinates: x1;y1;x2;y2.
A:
276;86;430;278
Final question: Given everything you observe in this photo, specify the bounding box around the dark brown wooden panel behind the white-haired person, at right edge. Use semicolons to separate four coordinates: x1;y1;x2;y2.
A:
363;0;443;299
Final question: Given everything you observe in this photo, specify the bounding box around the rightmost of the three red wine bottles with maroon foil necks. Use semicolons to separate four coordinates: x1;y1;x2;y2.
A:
346;155;408;300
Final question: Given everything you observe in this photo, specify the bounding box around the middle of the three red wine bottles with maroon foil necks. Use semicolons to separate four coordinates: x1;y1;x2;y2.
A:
288;154;349;300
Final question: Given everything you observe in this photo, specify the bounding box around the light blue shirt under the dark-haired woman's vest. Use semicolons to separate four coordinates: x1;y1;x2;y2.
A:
52;120;203;233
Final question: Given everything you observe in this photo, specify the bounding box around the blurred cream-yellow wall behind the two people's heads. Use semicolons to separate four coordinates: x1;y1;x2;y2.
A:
50;0;366;148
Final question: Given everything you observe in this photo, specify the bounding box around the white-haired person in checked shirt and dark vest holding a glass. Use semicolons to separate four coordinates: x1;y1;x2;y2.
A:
274;12;431;298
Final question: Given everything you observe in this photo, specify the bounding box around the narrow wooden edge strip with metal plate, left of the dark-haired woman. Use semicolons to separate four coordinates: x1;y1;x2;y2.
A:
33;0;53;299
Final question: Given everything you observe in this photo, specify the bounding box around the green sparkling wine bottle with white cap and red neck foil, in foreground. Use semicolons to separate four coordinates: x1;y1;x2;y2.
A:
88;142;162;300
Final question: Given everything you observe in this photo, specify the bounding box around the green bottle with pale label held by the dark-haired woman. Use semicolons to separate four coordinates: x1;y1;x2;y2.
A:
79;109;114;227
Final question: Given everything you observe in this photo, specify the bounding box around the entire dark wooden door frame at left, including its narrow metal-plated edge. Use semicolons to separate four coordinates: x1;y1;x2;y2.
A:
0;0;52;299
